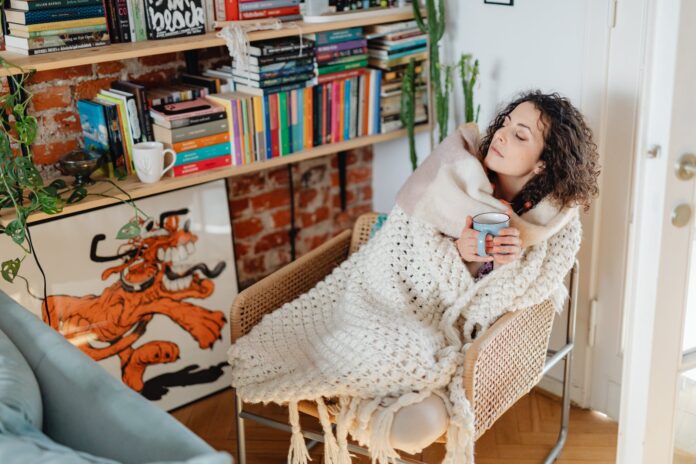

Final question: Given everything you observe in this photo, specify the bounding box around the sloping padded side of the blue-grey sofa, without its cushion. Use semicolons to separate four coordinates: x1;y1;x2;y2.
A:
0;292;226;464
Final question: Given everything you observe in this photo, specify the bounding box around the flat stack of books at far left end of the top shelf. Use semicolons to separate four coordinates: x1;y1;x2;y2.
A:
5;0;110;55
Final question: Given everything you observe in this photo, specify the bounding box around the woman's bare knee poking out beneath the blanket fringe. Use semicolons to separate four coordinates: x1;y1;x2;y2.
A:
390;394;449;453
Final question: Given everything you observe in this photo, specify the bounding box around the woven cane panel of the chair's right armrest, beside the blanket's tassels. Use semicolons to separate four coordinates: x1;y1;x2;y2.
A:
464;300;555;439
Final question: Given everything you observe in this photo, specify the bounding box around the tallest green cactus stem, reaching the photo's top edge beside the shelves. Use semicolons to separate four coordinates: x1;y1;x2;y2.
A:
413;0;449;143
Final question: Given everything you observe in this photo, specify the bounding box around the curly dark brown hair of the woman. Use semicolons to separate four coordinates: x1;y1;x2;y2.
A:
479;90;600;211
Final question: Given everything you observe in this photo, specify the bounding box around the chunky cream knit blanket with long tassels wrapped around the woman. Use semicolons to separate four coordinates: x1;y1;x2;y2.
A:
229;127;581;464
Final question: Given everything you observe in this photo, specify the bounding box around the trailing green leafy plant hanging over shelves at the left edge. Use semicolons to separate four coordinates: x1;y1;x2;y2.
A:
0;57;148;283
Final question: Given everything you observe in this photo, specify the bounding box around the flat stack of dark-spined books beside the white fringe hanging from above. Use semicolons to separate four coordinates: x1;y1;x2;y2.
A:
232;37;315;96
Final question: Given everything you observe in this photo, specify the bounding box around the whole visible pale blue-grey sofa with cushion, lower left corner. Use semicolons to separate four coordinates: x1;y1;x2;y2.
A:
0;292;232;464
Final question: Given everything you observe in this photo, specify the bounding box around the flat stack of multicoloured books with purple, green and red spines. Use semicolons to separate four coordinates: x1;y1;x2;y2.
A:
315;27;368;84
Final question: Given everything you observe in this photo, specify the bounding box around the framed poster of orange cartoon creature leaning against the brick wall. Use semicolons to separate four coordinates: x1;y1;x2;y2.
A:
0;180;237;410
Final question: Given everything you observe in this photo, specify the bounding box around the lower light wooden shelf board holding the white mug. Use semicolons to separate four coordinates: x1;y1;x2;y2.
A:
0;124;430;226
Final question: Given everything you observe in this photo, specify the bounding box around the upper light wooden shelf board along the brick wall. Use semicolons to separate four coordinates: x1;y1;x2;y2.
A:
0;11;413;77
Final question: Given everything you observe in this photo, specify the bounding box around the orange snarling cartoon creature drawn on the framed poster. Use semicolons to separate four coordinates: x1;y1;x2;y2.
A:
43;209;227;392
